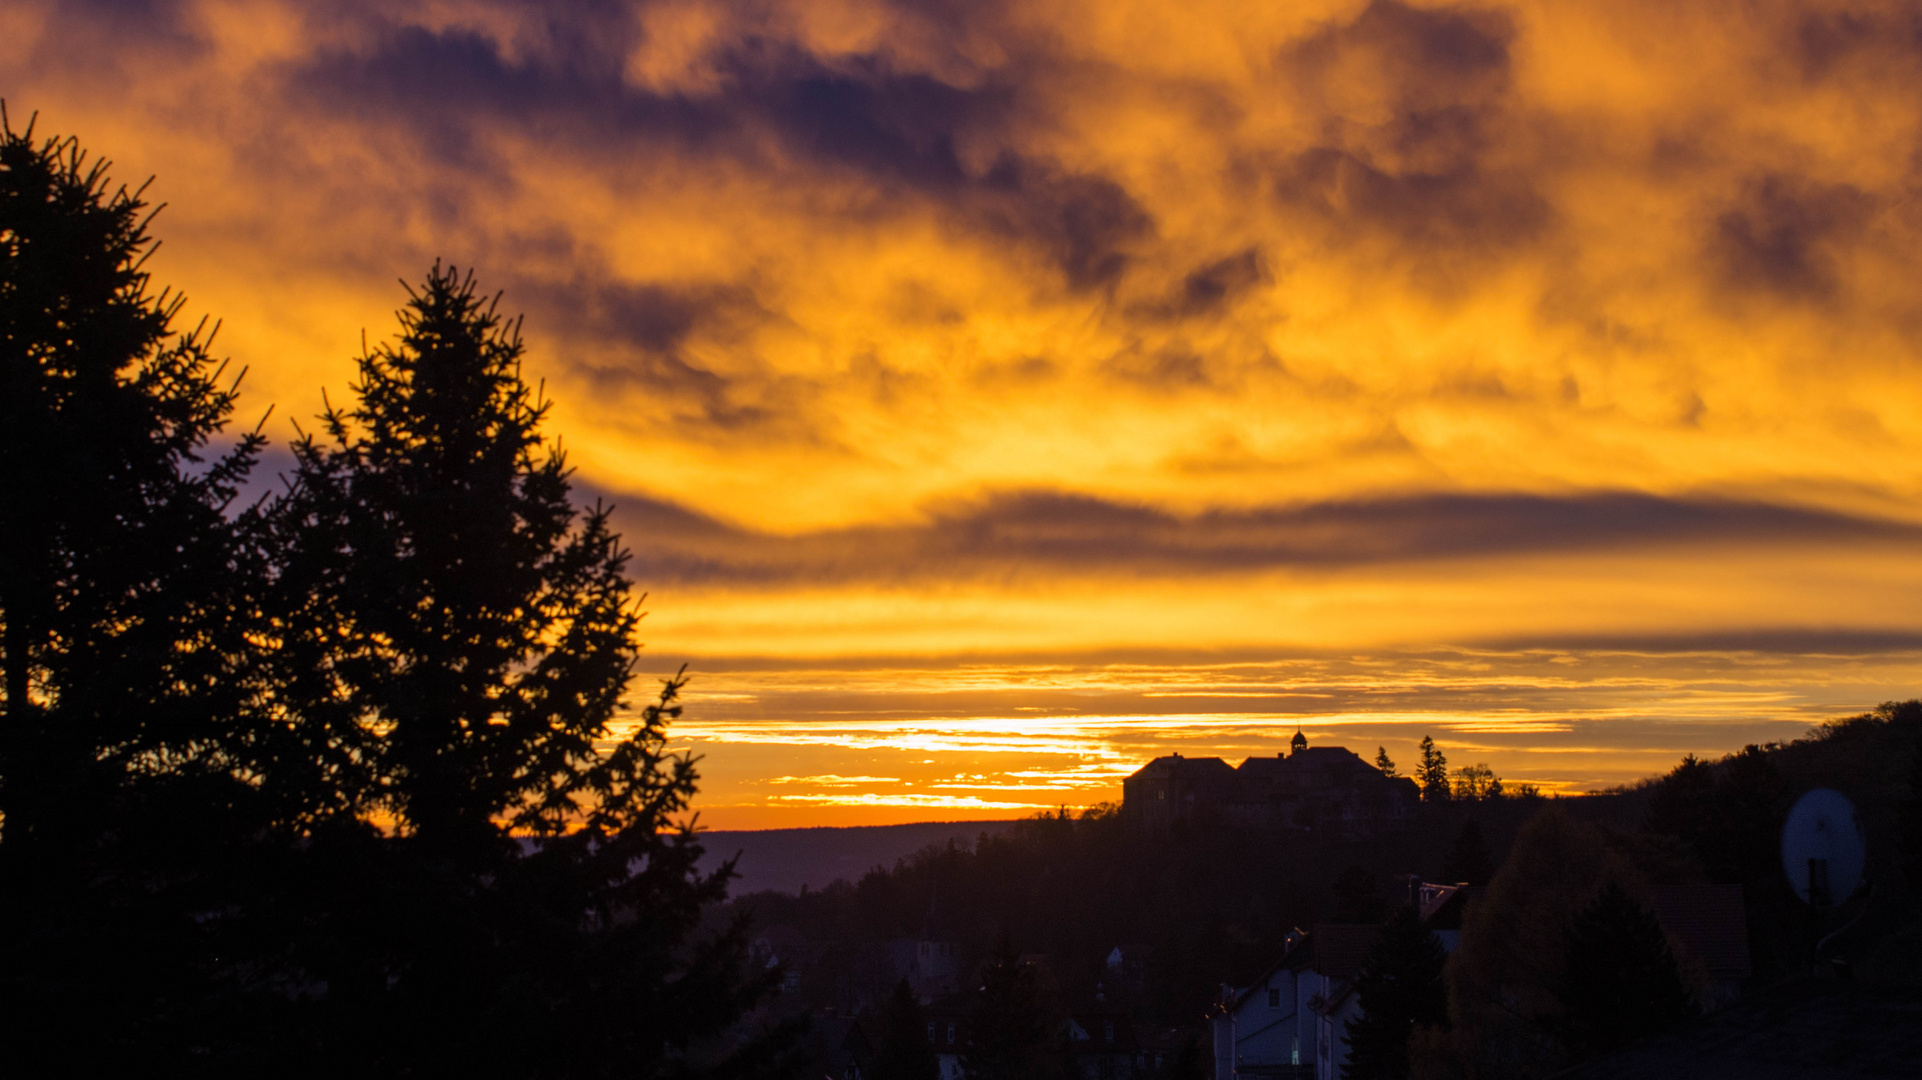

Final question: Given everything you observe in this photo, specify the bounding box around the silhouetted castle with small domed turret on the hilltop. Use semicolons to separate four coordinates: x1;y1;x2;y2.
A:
1121;730;1420;836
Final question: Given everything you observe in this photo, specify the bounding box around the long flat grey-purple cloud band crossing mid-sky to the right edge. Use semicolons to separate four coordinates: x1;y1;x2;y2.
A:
615;494;1922;584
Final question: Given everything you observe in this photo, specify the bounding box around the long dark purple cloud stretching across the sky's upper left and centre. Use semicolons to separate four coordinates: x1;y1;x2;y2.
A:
288;6;1153;290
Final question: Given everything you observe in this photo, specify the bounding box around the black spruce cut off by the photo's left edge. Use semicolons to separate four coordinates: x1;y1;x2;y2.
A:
0;115;271;1074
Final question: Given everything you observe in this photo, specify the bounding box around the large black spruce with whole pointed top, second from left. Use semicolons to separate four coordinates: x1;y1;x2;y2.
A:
271;263;782;1076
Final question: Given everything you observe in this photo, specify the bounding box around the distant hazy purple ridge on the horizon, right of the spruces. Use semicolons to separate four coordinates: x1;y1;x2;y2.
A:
702;821;1015;896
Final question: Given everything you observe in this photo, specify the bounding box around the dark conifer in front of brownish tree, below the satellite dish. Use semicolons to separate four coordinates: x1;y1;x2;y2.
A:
1557;884;1697;1059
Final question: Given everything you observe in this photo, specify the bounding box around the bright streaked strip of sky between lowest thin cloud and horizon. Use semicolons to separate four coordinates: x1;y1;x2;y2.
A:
653;648;1922;828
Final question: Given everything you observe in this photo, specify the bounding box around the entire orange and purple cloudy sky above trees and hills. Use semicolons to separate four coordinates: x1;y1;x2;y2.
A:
15;0;1922;828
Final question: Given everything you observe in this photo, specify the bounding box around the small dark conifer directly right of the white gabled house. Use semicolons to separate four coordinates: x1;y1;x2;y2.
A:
1342;907;1447;1080
